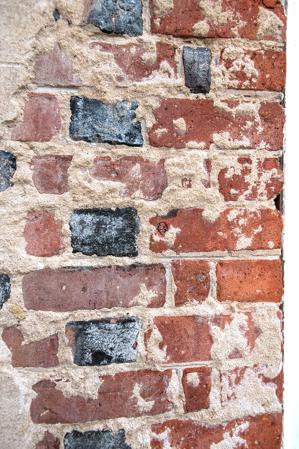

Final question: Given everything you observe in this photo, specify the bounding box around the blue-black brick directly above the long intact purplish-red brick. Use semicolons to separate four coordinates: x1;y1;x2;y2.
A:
70;207;139;257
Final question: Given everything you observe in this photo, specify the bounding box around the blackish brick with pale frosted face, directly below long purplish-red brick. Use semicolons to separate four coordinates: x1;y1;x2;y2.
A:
66;318;139;366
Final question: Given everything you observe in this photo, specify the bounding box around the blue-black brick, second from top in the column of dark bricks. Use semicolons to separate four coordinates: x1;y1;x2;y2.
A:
70;97;143;146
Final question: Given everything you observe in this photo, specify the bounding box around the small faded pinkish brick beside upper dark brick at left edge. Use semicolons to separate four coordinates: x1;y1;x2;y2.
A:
32;155;73;195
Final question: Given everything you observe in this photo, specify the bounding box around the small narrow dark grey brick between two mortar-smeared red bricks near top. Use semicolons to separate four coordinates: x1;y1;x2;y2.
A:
183;47;211;94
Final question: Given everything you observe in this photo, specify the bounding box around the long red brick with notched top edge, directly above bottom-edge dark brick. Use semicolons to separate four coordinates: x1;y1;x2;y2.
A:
31;370;173;424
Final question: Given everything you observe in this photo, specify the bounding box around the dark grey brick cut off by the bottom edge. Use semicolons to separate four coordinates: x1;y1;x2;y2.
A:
64;429;131;449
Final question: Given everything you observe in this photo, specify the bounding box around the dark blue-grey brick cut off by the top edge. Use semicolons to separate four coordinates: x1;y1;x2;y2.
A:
87;0;143;36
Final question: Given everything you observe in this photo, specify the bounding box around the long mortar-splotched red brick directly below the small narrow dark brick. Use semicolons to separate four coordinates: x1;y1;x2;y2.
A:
149;98;284;150
